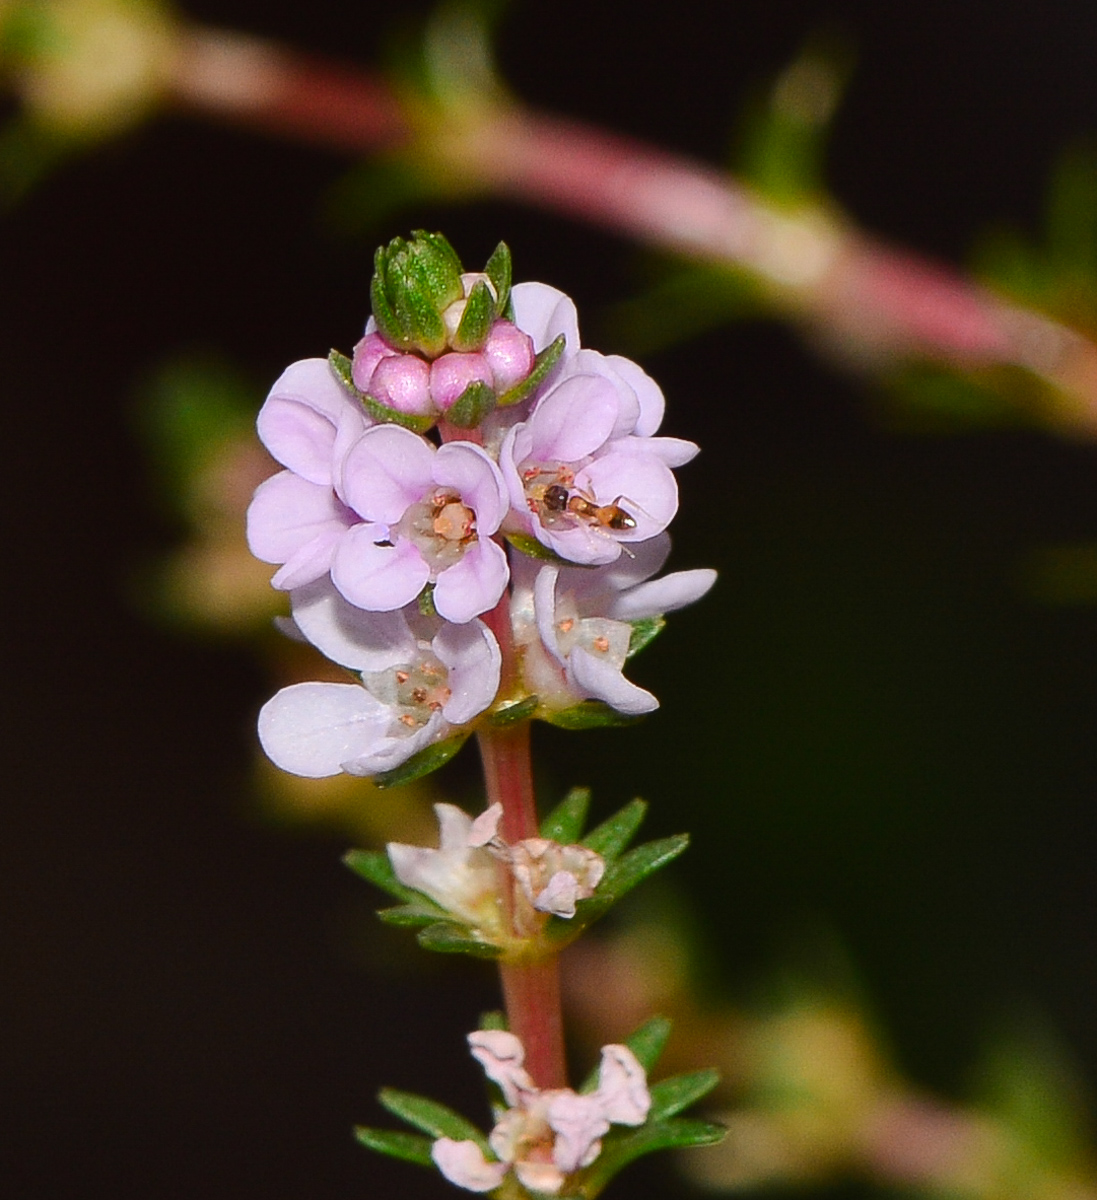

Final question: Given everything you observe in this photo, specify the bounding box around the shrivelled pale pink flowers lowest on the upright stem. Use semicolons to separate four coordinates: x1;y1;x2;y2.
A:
431;1030;652;1195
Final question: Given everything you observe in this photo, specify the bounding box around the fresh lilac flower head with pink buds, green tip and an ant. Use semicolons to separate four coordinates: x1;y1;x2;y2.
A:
247;234;715;776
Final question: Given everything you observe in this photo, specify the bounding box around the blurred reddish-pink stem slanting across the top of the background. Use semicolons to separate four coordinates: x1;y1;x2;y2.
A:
168;28;1097;436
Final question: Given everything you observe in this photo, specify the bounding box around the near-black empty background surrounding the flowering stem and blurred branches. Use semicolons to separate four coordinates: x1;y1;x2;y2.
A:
0;0;1097;1200
